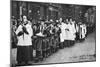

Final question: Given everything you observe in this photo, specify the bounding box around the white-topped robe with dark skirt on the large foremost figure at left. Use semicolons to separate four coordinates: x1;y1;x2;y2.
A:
15;24;33;63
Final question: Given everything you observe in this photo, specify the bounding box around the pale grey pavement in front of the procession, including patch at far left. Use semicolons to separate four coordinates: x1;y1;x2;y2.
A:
11;32;96;64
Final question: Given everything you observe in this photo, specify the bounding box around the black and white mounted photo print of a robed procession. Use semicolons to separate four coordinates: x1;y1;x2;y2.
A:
10;0;96;67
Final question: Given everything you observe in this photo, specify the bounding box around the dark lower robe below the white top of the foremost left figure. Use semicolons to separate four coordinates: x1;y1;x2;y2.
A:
17;46;32;64
